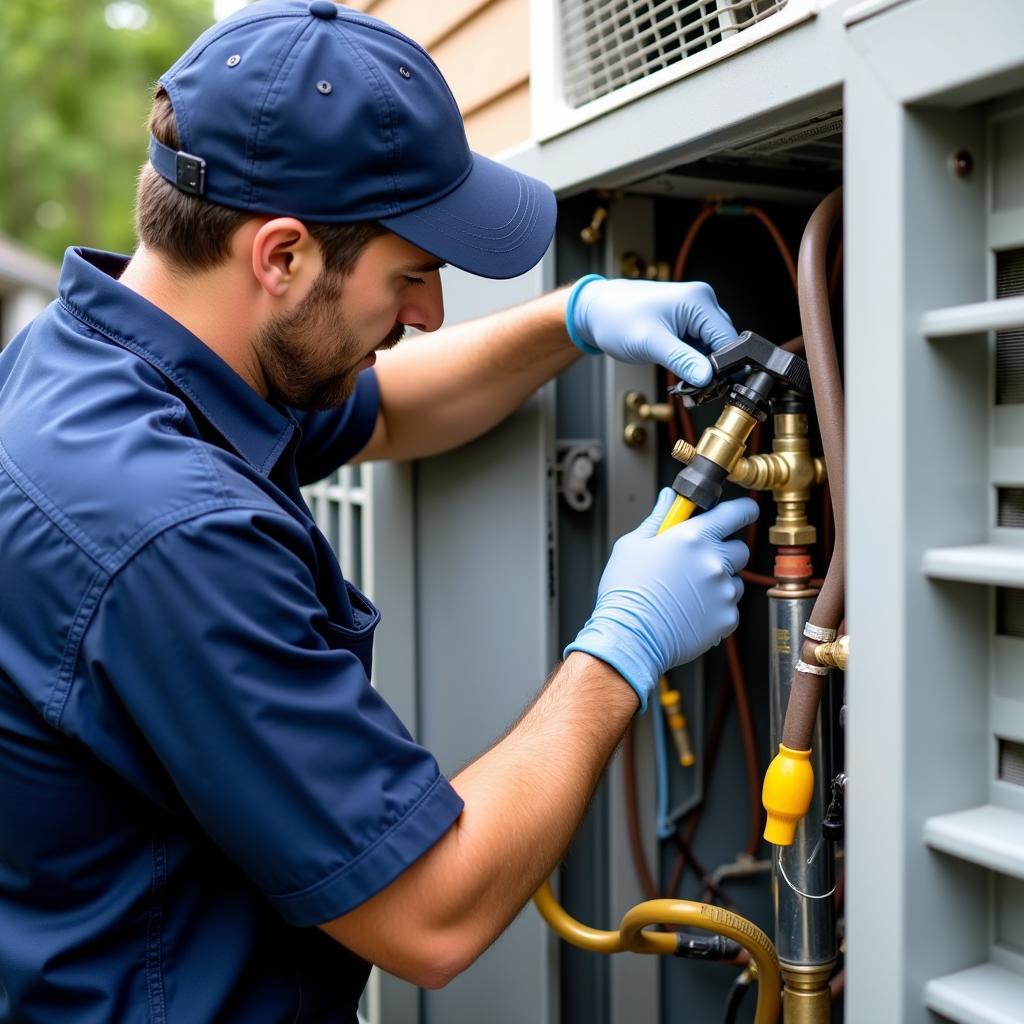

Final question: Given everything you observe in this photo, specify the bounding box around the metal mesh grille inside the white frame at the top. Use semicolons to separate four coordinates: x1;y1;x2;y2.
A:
559;0;787;108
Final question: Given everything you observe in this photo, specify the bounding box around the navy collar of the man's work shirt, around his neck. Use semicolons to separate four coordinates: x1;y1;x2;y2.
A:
58;248;296;474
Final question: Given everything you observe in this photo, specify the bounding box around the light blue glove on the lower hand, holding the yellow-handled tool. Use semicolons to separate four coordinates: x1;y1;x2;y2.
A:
563;487;758;714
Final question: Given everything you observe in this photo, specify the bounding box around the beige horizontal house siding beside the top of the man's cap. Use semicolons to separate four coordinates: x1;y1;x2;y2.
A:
349;0;529;156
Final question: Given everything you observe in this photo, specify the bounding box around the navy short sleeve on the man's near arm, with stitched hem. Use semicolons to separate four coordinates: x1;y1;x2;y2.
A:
80;508;462;927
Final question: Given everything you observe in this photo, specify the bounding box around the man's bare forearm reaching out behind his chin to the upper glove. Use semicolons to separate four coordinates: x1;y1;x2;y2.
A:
361;290;580;459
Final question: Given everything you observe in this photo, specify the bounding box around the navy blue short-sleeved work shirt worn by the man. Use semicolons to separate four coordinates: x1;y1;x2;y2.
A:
0;250;462;1024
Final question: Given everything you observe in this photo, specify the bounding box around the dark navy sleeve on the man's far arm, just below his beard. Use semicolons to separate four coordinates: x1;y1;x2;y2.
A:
291;369;381;486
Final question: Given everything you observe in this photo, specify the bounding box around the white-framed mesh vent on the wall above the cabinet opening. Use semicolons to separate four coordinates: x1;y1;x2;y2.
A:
530;0;829;141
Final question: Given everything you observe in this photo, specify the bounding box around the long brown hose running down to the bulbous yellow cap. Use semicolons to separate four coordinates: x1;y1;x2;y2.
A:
782;188;846;751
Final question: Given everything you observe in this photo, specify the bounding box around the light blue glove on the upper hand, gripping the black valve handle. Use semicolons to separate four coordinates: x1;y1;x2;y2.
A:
565;273;736;384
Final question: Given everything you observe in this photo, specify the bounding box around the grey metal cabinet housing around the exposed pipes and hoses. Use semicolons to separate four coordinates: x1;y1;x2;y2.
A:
377;0;1024;1024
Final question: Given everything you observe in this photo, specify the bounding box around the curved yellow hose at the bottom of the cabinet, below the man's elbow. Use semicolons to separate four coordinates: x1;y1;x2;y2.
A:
534;882;782;1024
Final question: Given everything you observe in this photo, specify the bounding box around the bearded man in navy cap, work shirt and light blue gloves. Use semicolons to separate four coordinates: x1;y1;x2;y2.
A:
0;0;755;1024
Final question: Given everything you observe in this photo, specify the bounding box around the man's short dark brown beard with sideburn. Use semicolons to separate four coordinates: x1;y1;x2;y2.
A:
253;270;378;410
